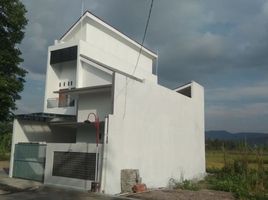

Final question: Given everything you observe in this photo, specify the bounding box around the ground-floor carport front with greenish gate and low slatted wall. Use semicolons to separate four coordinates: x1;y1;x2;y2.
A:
10;113;105;190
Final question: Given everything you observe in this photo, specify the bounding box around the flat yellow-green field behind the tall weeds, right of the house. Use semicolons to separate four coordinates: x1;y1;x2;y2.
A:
206;150;268;170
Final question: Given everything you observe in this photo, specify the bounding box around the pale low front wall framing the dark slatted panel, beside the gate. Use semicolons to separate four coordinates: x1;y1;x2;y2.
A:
44;143;102;190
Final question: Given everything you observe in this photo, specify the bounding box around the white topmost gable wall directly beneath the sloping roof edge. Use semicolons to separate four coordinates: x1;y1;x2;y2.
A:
60;13;157;81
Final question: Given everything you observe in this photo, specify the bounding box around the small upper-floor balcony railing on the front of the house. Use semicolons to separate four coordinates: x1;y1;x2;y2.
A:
47;95;75;108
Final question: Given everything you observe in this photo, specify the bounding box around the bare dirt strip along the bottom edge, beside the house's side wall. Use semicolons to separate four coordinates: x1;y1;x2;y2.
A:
128;190;235;200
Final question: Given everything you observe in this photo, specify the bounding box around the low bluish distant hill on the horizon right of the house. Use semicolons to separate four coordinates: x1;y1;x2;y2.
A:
205;130;268;145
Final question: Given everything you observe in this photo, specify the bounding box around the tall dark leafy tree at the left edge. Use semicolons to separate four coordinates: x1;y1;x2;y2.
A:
0;0;27;122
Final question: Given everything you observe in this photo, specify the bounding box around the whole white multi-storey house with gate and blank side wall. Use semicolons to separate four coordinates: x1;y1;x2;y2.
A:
10;12;205;194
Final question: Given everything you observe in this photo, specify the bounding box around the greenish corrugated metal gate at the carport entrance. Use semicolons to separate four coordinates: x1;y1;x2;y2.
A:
13;143;46;182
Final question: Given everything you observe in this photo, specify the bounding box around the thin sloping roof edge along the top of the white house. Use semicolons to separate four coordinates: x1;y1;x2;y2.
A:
60;11;157;58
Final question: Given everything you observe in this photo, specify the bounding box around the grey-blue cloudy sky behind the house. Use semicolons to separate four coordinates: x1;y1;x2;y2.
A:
17;0;268;133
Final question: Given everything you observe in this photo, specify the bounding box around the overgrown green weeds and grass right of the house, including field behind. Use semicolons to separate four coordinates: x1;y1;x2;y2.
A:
205;145;268;200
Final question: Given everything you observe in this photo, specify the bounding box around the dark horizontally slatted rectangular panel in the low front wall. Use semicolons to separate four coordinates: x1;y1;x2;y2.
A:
52;151;96;181
